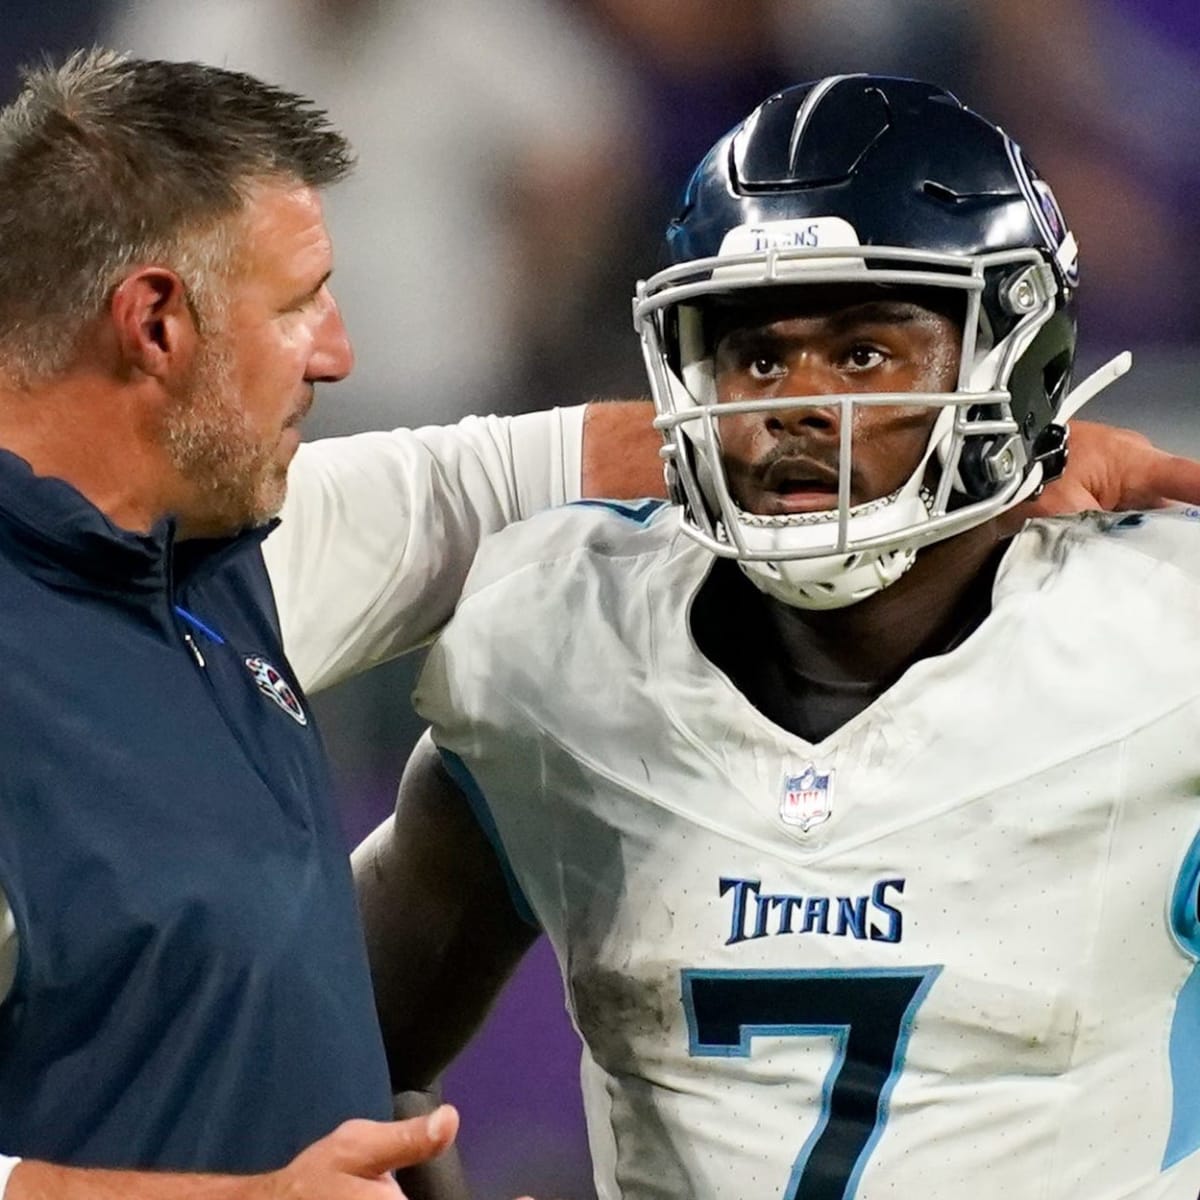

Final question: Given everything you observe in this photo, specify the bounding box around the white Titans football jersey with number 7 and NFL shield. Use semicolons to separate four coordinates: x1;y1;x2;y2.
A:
418;503;1200;1200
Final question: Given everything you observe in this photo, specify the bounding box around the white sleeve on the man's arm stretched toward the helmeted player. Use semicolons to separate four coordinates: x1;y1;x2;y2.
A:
264;407;583;691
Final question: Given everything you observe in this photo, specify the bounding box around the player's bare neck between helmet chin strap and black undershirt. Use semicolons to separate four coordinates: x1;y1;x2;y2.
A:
767;524;1003;690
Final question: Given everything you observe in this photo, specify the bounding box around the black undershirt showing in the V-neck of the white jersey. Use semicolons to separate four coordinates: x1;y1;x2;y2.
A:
691;546;1003;743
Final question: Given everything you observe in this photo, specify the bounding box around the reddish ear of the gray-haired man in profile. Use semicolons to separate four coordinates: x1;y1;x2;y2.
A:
109;266;199;379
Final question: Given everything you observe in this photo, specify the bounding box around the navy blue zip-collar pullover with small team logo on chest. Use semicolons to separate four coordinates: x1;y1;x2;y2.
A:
0;451;390;1171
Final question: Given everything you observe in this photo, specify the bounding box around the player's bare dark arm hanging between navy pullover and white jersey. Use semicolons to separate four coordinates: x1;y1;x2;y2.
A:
353;733;538;1200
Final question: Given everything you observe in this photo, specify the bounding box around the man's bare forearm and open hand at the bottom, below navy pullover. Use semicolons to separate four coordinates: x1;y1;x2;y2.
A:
2;1108;458;1200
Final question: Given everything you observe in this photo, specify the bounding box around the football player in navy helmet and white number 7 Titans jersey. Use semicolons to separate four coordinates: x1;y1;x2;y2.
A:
356;76;1200;1200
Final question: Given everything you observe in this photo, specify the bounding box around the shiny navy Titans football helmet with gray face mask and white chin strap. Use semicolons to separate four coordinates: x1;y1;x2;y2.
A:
634;76;1129;608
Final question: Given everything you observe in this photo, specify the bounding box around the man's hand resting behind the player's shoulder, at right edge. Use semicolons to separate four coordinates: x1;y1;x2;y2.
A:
1003;421;1200;530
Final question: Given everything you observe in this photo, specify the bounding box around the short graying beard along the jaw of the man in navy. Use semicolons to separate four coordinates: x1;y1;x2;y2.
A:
163;331;287;536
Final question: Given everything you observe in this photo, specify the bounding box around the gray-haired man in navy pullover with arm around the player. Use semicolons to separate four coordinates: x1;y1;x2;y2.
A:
0;44;1200;1200
